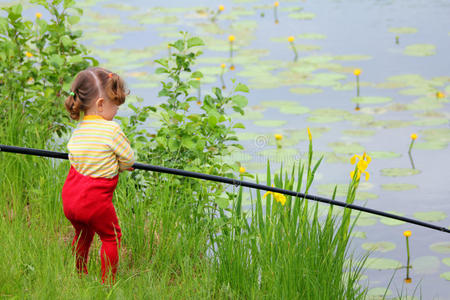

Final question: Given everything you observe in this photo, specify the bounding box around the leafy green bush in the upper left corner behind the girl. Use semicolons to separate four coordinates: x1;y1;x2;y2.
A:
0;0;97;145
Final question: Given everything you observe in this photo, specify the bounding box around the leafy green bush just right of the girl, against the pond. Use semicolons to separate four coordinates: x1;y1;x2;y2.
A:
120;33;249;206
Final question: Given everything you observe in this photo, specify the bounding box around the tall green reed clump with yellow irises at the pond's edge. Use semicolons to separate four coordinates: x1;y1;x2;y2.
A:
211;142;366;299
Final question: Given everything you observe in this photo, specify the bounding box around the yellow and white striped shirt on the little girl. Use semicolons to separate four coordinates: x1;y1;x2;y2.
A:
67;115;134;178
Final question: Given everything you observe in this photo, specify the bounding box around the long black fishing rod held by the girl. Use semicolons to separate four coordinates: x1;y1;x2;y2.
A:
0;145;450;233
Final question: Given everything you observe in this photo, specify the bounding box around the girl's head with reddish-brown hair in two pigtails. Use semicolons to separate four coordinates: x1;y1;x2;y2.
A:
64;67;129;120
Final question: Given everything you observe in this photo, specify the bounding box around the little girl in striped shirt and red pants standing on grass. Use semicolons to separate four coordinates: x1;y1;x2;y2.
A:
62;68;134;283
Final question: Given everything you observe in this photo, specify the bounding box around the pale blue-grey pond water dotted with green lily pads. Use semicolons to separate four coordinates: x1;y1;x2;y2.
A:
18;0;450;299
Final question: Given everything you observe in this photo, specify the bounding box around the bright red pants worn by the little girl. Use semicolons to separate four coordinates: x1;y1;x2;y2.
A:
62;166;122;283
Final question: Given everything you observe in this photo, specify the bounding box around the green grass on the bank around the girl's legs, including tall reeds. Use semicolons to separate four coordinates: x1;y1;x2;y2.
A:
0;119;366;299
